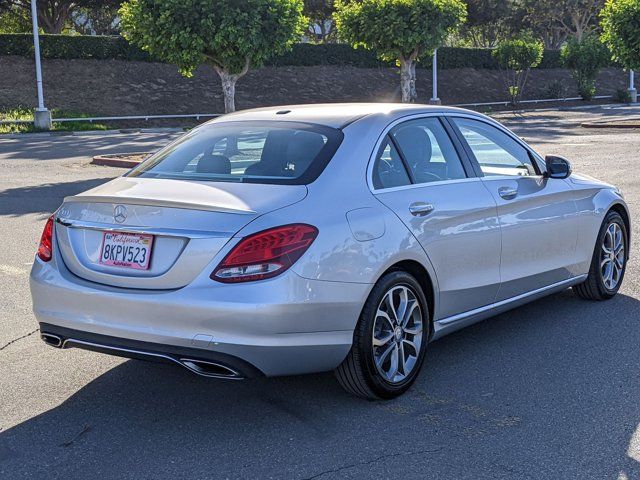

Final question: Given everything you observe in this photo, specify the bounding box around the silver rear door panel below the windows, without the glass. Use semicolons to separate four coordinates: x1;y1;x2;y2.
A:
376;178;500;319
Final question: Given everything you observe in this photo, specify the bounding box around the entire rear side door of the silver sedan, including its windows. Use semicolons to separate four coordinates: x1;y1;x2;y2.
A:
373;117;500;319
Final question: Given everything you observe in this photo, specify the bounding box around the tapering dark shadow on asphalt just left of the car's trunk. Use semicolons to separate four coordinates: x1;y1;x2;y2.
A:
0;177;112;217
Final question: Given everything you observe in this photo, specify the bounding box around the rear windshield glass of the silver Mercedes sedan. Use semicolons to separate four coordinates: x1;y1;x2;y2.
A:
127;122;343;185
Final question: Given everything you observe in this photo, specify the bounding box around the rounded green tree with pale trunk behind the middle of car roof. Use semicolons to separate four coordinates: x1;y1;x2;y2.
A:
334;0;466;102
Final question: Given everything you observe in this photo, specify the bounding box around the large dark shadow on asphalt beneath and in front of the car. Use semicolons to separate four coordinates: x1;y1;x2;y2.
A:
0;291;640;479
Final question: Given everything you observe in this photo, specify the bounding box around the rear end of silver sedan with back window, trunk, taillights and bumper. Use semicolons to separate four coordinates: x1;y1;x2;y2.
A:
31;122;366;378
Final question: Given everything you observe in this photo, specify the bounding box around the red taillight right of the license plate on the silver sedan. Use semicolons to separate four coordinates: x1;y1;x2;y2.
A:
211;223;318;283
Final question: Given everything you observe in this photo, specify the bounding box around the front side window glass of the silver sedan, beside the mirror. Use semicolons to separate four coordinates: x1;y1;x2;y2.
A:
452;118;537;176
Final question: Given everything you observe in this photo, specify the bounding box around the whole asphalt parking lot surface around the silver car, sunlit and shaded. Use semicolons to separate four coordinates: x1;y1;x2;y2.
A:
0;108;640;480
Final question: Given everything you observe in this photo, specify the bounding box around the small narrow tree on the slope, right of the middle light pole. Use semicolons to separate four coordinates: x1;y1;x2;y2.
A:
493;38;544;105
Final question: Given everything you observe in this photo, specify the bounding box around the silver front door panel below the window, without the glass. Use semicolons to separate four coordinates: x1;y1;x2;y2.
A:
482;176;578;301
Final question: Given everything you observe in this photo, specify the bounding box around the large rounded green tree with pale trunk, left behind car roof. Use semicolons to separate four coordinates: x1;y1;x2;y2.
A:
120;0;306;112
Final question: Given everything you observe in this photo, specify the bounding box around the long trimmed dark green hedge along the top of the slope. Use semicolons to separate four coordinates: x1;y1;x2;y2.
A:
0;33;608;70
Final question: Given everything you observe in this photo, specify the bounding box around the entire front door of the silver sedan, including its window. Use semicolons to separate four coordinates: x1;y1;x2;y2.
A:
452;118;578;301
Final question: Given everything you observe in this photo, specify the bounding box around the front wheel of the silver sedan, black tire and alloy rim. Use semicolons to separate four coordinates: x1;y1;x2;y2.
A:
573;211;629;301
